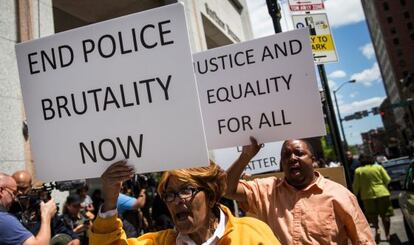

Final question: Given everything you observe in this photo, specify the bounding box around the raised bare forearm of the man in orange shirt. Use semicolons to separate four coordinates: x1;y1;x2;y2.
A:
225;137;262;202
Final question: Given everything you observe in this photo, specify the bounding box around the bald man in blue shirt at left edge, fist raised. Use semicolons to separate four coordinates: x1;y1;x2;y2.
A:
0;173;56;245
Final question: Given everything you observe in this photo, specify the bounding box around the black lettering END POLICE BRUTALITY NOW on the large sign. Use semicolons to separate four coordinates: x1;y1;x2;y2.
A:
27;20;174;164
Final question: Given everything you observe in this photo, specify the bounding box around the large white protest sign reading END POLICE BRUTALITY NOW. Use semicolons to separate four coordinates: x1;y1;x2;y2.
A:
16;4;208;181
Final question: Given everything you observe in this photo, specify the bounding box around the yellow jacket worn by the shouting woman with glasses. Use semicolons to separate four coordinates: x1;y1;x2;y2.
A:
89;206;280;245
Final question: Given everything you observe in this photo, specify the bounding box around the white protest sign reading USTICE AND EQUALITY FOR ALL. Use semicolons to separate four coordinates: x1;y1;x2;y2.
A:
193;29;325;150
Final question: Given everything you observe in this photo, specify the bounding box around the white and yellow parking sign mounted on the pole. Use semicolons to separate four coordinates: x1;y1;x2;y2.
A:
292;14;338;64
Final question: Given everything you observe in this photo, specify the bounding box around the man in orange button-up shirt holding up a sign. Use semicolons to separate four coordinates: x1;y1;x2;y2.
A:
226;138;375;244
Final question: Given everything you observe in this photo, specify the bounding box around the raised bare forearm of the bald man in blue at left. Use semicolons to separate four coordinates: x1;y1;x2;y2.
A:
23;199;57;245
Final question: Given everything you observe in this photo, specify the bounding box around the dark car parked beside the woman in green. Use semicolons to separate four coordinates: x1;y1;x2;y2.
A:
382;156;411;190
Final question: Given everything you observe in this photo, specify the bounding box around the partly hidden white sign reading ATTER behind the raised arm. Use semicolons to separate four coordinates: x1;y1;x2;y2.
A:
213;141;283;175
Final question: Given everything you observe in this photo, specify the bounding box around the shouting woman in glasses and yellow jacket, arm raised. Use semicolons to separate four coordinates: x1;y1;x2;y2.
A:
89;161;280;245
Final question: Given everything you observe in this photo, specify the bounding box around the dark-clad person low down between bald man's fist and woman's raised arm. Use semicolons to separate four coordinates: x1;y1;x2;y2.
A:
60;194;91;244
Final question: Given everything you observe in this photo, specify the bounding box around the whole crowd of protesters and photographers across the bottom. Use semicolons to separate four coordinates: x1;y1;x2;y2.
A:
0;138;393;245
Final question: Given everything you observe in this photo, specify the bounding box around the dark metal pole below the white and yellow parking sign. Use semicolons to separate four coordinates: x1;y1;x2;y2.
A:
318;64;352;187
